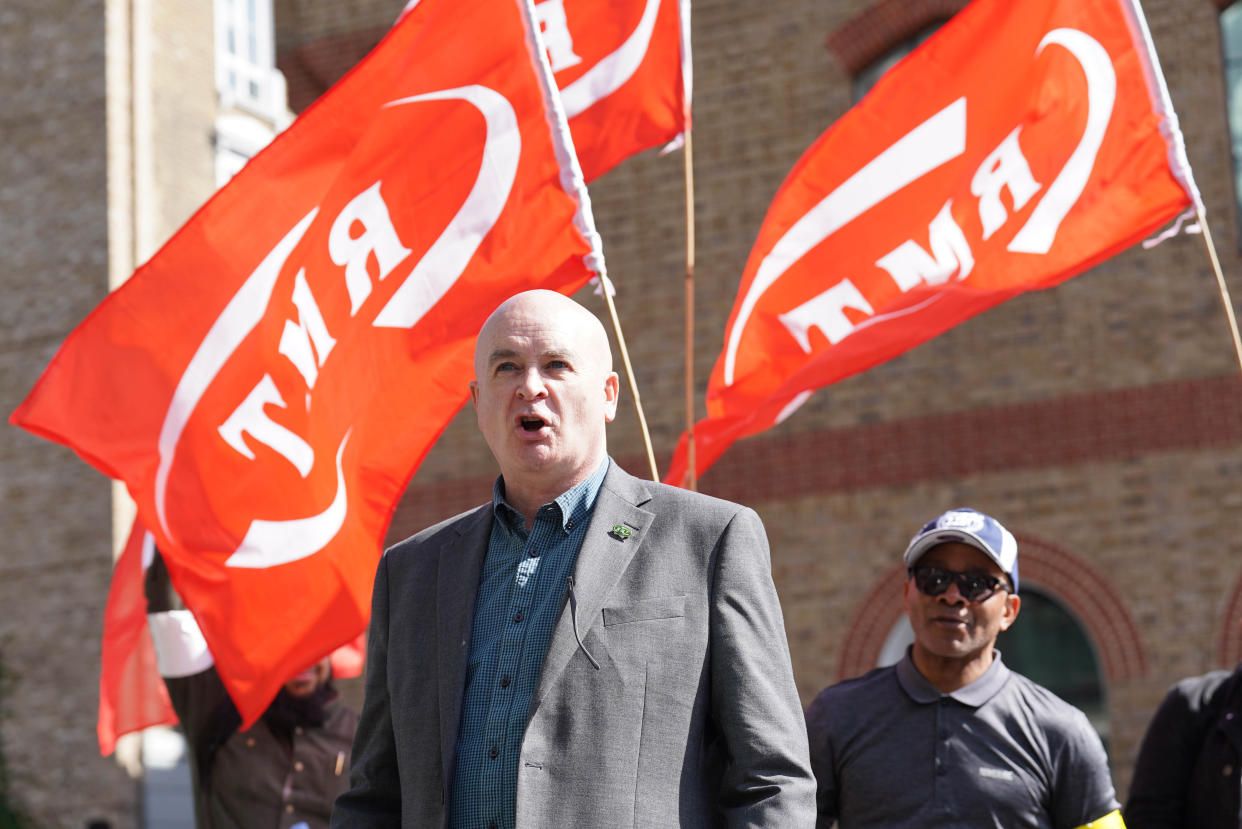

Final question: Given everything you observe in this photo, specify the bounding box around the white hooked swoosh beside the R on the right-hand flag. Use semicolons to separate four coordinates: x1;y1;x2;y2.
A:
1009;29;1117;254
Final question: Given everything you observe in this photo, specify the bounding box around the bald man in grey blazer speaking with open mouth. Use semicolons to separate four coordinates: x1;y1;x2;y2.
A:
333;291;815;829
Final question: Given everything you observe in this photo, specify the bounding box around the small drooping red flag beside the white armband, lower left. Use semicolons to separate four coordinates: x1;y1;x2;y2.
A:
96;518;176;757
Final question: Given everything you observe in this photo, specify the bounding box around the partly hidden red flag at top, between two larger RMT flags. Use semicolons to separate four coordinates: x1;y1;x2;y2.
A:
535;0;689;181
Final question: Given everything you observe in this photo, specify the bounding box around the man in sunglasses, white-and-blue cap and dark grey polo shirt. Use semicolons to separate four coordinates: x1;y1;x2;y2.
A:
806;510;1124;829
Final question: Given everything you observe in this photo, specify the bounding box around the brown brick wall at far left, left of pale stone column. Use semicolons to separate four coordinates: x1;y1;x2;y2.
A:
0;0;135;827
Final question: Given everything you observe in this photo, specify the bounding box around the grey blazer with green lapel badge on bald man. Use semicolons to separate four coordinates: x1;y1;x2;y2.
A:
332;464;815;829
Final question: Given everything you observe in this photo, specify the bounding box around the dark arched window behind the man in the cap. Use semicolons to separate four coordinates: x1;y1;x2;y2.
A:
878;584;1109;747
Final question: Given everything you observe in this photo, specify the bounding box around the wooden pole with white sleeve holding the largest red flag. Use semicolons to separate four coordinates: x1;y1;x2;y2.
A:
515;0;660;481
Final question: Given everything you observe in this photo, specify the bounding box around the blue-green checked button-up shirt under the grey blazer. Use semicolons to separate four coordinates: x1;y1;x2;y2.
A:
448;460;609;829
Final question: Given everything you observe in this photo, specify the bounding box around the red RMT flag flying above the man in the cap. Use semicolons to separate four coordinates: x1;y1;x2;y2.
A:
666;0;1199;483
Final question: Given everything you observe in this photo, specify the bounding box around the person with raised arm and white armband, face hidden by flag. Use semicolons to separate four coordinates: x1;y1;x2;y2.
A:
144;553;358;829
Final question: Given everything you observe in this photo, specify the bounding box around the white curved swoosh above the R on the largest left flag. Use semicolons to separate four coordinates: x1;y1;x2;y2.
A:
374;85;522;328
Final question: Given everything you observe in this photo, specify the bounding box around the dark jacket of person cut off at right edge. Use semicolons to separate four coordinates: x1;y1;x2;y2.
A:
1125;665;1242;829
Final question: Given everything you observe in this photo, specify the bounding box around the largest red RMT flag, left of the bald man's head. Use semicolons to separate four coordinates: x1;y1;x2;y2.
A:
11;0;594;725
